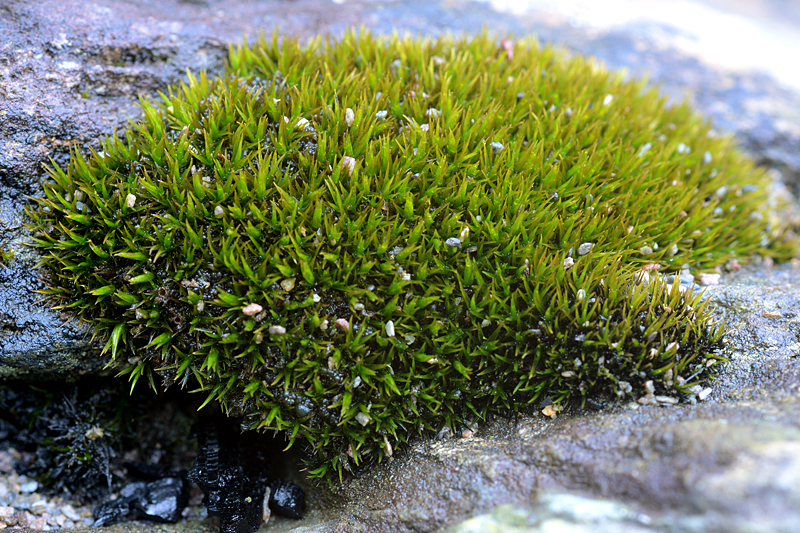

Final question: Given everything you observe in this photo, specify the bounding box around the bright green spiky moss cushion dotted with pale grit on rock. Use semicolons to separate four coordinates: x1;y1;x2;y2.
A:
30;32;797;475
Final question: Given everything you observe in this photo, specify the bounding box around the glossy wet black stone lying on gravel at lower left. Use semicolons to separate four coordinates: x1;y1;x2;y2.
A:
94;476;189;527
